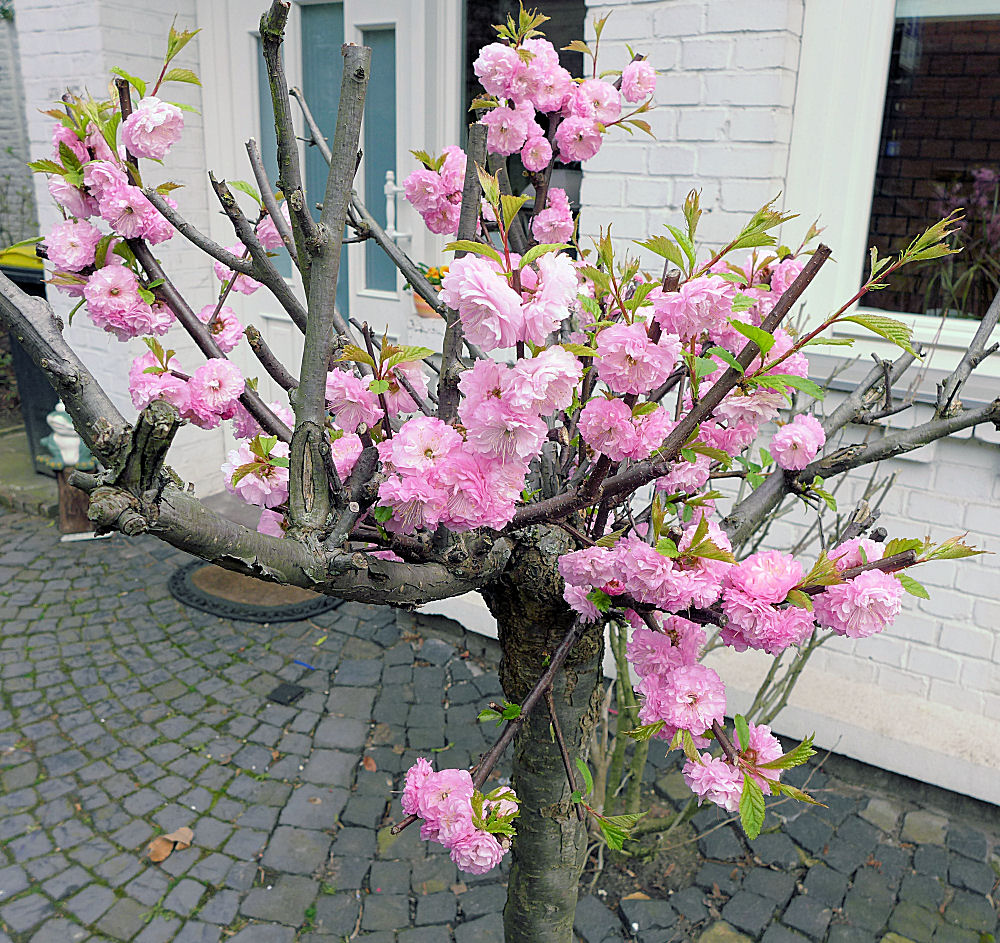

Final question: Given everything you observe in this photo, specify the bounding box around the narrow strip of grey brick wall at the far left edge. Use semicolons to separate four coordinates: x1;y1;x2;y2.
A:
0;19;38;249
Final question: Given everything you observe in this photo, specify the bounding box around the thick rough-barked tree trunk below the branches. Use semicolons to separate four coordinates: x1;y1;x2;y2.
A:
483;528;604;943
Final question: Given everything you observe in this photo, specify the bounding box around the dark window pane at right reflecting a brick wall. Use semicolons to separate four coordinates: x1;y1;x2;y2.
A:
865;0;1000;318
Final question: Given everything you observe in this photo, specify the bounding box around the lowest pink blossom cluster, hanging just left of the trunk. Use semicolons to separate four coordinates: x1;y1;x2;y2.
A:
402;757;517;874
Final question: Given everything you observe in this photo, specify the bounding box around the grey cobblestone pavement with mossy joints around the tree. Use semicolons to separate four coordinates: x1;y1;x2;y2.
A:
0;510;1000;943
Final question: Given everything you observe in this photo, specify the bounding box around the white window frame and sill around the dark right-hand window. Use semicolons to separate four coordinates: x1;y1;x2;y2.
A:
785;0;1000;376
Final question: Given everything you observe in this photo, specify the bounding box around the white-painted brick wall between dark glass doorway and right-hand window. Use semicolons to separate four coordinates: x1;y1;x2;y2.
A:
581;0;802;251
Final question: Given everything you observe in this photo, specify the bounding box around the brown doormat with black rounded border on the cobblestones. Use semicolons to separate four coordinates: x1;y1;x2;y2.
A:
167;560;343;623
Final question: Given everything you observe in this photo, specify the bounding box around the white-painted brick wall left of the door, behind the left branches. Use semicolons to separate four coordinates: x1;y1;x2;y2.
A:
16;0;224;494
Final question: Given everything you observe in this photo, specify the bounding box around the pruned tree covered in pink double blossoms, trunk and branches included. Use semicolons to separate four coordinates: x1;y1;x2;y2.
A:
0;0;1000;941
